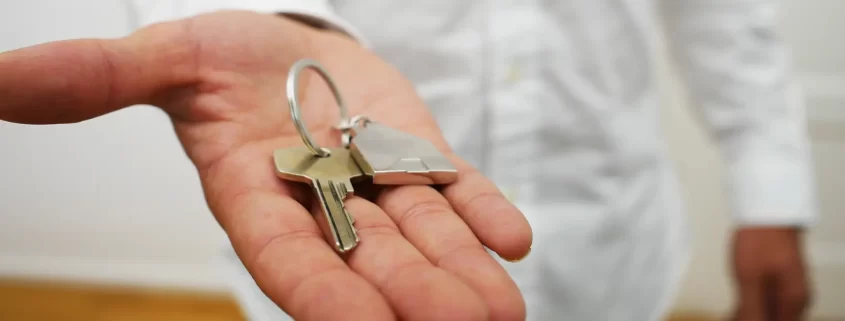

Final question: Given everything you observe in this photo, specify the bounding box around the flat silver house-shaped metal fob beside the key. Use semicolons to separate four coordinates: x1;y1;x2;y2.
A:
349;121;458;185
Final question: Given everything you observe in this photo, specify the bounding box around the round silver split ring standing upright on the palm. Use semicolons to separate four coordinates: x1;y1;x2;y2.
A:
287;59;354;157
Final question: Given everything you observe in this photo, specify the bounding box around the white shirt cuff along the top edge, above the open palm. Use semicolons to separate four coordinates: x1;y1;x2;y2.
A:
124;0;369;47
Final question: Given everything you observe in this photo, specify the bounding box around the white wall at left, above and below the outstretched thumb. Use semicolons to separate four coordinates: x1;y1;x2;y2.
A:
0;0;231;288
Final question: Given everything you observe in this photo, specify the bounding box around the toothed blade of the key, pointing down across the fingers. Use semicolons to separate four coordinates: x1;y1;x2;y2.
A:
313;179;360;253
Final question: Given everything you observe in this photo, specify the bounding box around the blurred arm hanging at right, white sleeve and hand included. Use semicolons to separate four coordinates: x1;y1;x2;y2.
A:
662;0;816;320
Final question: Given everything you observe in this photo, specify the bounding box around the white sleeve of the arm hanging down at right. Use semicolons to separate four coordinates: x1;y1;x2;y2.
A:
662;0;817;225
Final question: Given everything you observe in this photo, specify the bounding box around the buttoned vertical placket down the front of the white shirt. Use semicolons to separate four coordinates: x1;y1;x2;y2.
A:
486;0;543;202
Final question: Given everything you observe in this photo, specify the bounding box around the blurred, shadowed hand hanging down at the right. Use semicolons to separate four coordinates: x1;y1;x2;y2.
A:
733;228;811;321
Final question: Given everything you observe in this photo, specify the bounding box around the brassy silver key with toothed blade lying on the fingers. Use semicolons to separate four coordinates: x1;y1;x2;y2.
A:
273;146;365;253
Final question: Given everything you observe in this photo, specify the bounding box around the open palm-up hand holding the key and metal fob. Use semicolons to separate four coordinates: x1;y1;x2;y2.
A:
0;12;532;321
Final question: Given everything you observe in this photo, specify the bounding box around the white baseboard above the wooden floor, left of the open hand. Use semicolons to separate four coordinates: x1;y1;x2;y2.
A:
0;253;230;293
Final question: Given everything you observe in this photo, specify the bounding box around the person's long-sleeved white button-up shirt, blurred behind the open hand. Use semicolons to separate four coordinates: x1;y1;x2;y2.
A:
127;0;816;321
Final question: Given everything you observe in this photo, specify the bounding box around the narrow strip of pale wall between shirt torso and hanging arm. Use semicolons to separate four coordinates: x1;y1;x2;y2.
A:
661;56;731;312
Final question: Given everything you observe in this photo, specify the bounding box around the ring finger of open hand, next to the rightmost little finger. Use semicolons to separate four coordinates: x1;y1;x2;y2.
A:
378;186;525;320
